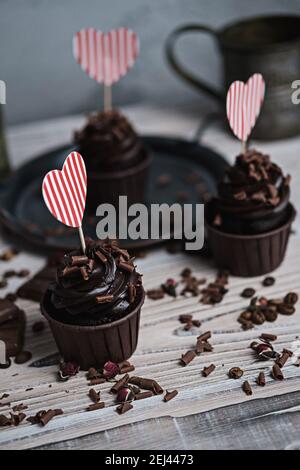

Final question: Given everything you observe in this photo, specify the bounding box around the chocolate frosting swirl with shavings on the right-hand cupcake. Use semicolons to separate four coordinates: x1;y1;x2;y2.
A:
213;149;290;233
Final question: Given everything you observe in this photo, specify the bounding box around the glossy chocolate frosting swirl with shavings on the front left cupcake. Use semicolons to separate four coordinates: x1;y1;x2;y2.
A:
49;240;141;322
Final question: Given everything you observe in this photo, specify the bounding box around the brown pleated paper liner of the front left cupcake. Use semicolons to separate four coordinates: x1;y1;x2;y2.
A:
41;289;145;370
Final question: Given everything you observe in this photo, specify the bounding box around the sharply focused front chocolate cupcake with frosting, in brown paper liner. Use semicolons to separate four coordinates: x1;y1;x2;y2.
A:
41;240;145;370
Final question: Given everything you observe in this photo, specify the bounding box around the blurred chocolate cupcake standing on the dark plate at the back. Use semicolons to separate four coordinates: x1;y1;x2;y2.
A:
75;111;151;214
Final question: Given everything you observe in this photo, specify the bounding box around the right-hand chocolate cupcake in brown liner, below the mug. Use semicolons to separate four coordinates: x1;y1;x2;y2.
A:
206;150;295;276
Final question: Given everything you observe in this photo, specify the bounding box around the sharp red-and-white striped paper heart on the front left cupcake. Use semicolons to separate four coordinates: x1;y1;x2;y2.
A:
42;152;87;227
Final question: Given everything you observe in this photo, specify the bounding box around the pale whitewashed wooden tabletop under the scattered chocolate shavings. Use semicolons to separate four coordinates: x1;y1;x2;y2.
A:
0;237;300;449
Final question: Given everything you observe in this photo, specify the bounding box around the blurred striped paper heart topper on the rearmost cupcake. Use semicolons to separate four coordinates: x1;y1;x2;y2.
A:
73;28;139;86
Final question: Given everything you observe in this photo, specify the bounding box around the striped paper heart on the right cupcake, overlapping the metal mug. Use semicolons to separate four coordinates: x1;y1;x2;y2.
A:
226;73;265;143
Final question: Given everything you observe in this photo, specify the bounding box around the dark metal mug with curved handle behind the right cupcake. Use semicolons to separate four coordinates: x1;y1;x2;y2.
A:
166;15;300;140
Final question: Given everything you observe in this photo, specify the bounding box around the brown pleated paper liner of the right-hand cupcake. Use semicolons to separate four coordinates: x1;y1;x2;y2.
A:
206;204;296;277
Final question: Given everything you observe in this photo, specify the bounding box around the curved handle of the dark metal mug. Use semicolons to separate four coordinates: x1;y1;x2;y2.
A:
165;24;224;102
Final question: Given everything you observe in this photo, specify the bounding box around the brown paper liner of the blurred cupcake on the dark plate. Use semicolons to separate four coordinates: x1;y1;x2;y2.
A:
87;151;152;215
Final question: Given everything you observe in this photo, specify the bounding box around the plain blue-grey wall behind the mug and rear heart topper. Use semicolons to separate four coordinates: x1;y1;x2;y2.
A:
0;0;300;123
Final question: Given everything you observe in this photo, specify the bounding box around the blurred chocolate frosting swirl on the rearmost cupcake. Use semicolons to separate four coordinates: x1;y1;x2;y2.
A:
74;111;143;172
